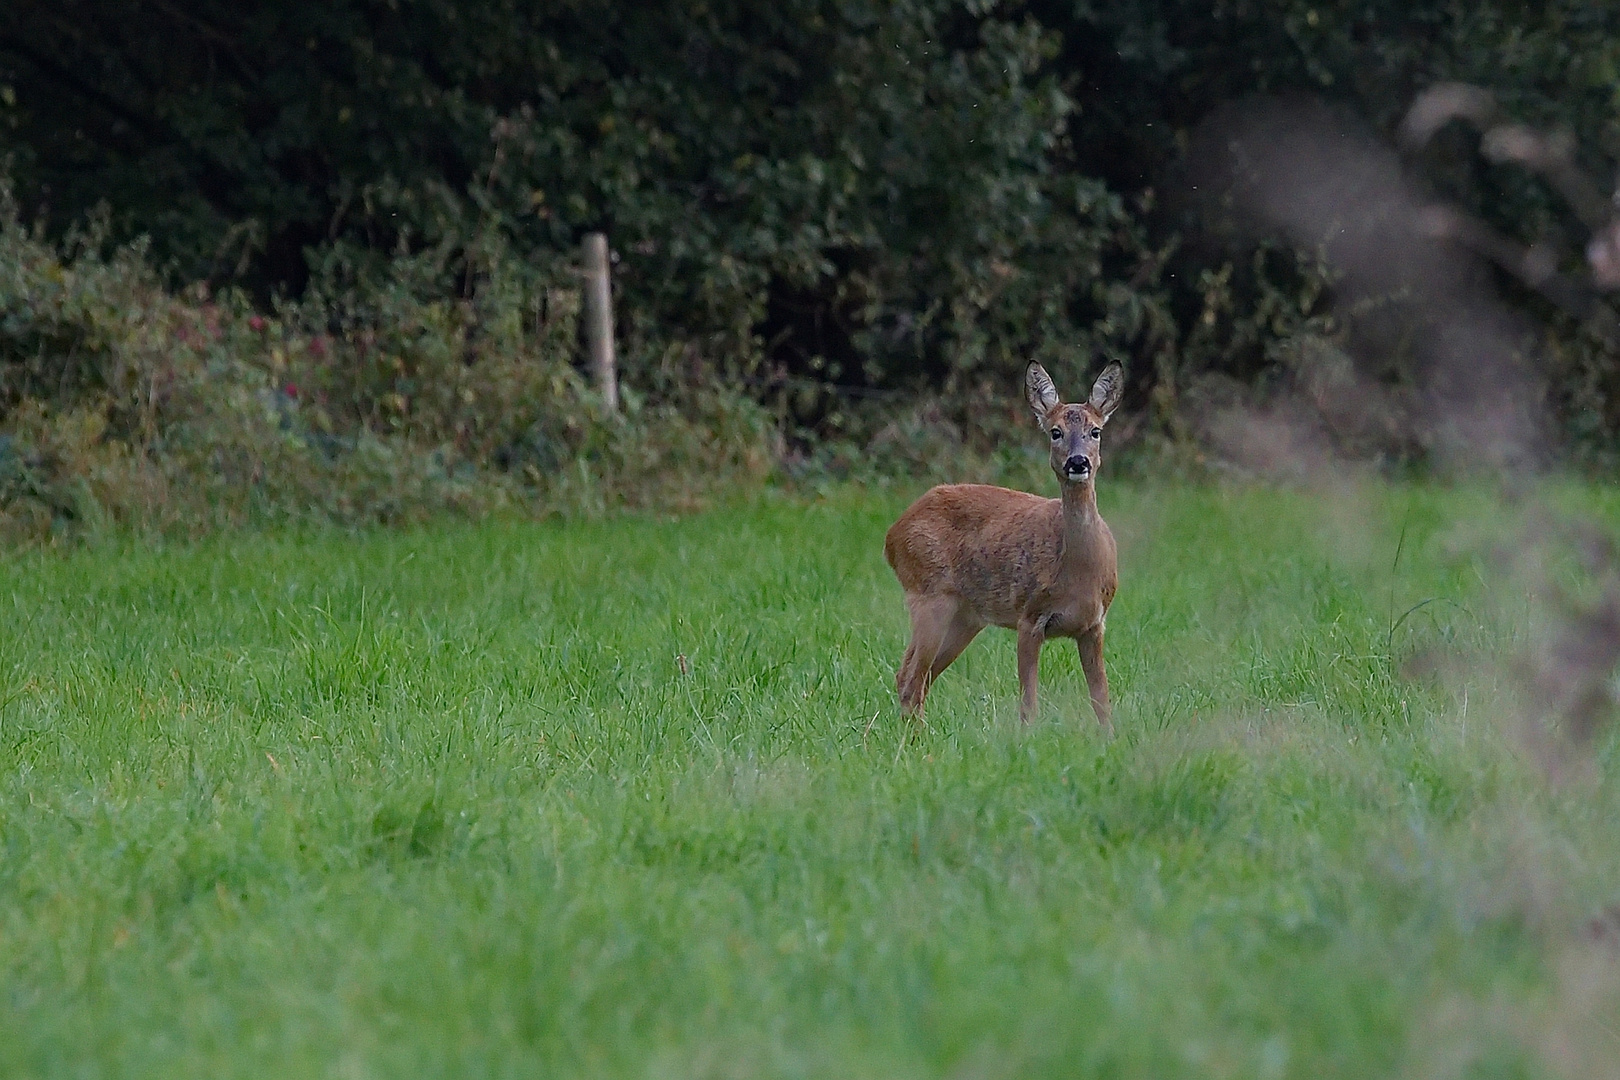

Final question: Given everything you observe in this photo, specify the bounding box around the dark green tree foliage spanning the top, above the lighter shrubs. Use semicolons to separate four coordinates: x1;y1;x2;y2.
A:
0;0;1620;459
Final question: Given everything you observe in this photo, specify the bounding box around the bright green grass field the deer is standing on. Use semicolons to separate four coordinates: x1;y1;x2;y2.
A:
0;478;1620;1078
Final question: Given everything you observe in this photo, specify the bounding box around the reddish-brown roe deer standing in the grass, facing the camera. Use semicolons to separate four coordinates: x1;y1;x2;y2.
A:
883;364;1124;733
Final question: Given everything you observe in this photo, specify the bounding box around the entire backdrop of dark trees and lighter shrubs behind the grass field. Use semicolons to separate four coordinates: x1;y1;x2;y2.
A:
0;0;1620;534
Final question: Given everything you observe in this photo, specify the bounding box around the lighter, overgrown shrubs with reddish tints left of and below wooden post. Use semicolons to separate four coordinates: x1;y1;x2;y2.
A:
0;189;773;534
